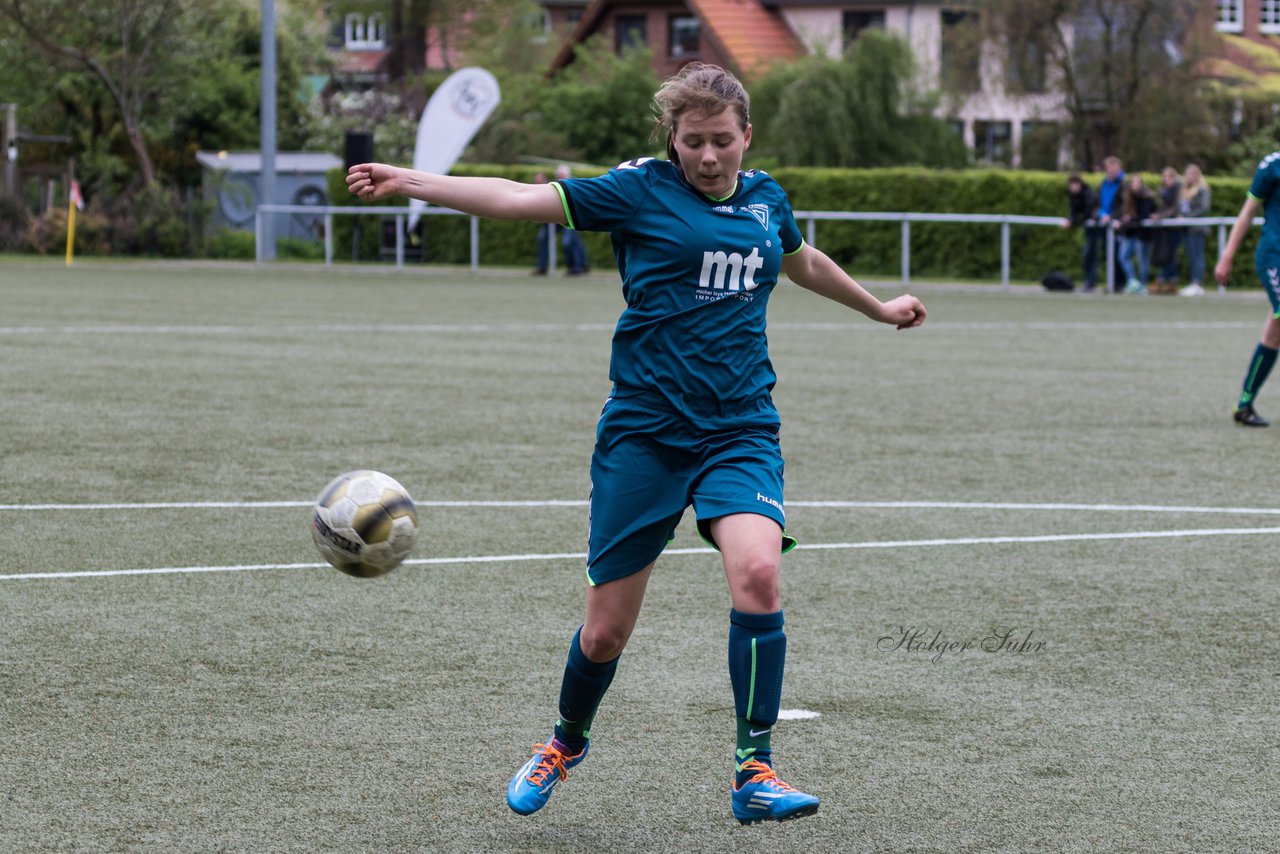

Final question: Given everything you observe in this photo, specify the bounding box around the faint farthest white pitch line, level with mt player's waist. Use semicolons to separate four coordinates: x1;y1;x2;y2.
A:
0;320;1257;335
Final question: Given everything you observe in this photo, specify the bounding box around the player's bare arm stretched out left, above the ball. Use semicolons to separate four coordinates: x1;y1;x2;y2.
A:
347;163;568;225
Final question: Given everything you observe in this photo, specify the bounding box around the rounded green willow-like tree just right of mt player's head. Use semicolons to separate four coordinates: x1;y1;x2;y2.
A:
751;29;968;168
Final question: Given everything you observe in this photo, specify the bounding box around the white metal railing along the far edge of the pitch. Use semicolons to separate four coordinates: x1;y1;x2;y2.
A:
253;205;1262;293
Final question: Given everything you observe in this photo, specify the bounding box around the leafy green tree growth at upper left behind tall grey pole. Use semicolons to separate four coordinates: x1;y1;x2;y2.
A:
0;0;324;196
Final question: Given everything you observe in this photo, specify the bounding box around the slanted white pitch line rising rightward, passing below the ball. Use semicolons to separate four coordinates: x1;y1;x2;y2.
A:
0;528;1280;581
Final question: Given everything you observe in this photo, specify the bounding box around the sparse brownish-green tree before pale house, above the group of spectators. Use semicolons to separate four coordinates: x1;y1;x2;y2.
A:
977;0;1215;169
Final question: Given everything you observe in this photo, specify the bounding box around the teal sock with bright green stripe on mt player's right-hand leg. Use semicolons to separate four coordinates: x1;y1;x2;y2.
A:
728;609;787;785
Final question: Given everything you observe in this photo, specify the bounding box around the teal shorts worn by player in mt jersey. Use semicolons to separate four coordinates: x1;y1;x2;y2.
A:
586;394;795;586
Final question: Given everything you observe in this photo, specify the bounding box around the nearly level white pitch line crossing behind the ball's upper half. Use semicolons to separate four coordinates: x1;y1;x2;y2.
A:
0;499;1280;516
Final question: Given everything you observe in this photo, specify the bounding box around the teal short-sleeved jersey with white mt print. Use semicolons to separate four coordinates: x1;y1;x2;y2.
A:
556;159;804;430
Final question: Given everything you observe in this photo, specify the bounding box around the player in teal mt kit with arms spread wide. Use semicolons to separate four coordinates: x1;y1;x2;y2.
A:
347;64;925;823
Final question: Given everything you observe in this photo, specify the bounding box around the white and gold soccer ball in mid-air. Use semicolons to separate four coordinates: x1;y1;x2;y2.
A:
311;471;417;579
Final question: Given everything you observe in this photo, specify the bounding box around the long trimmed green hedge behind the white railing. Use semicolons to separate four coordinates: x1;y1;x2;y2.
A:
329;165;1257;284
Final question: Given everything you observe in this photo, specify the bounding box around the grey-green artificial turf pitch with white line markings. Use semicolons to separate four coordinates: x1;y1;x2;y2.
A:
0;260;1280;853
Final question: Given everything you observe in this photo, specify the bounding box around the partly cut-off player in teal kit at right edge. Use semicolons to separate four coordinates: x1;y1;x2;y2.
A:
1213;151;1280;426
